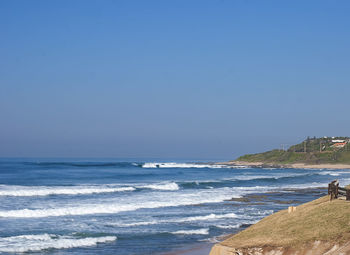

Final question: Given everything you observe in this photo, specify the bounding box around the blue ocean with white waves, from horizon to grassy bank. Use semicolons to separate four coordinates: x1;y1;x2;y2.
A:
0;159;350;255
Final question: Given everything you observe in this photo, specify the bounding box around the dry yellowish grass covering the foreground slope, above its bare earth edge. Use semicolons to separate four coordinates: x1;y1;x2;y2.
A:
222;196;350;248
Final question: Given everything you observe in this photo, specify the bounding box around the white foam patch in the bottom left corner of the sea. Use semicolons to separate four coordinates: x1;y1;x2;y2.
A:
0;234;117;253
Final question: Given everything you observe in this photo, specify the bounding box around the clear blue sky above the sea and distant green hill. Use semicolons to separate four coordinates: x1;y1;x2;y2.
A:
0;0;350;159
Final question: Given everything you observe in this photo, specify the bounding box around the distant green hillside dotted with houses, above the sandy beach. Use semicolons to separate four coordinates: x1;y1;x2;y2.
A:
233;137;350;164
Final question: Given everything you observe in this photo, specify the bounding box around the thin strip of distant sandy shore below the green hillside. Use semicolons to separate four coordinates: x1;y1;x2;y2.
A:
216;161;350;169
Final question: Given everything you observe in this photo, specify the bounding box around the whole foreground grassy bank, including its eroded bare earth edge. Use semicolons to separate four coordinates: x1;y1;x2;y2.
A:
210;196;350;255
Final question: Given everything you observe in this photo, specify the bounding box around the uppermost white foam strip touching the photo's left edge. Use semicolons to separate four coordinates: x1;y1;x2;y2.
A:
0;185;135;197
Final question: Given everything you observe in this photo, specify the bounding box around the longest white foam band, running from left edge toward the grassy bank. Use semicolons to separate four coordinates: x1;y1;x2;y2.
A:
0;179;327;218
